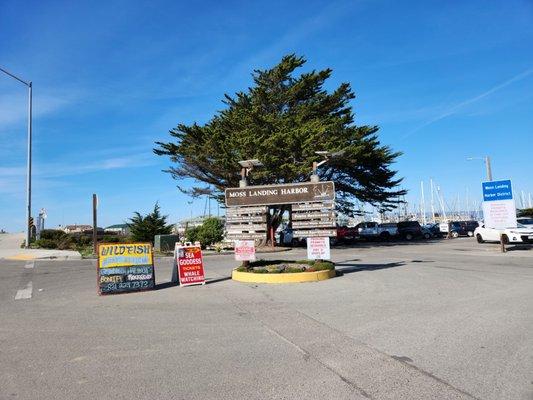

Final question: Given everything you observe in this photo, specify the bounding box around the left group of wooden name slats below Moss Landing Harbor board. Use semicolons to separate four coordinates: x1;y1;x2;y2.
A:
226;206;267;240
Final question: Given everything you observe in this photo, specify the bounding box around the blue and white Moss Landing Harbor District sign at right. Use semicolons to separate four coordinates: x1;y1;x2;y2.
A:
482;179;516;229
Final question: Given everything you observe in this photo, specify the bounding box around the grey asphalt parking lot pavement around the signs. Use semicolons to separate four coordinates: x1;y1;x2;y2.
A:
0;238;533;400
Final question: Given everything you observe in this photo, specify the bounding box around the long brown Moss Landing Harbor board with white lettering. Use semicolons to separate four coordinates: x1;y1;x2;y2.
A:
225;182;335;207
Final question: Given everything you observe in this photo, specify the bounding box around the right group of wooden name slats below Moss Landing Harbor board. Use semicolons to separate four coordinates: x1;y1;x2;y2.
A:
291;201;337;238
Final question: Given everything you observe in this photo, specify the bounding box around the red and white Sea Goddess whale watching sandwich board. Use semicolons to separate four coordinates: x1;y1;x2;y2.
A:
172;243;205;286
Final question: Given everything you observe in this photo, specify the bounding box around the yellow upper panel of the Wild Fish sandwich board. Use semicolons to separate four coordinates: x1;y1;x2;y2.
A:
98;243;153;268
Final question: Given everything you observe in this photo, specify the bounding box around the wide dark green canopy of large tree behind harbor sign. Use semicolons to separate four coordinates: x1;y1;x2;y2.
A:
154;54;405;215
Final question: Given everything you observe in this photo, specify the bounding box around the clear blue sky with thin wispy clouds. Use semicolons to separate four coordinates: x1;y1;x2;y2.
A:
0;0;533;231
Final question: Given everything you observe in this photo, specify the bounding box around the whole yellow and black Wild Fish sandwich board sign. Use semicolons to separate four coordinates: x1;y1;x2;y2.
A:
96;243;155;295
